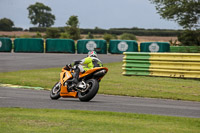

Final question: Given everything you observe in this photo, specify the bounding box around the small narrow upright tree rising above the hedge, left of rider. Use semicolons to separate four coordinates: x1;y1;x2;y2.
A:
66;16;80;40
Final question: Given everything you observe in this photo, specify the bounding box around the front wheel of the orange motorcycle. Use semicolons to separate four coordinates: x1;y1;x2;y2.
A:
50;82;60;100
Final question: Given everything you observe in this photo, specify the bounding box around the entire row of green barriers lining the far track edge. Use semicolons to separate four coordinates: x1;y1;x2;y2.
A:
3;37;200;54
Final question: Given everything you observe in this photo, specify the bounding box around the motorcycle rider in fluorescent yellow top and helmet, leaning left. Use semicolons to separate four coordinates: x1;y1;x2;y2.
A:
67;51;103;84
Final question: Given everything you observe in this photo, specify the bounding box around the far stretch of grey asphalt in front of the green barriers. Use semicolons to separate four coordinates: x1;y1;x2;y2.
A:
0;53;123;72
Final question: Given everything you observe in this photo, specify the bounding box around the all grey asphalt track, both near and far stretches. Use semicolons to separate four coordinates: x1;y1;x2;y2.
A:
0;53;200;118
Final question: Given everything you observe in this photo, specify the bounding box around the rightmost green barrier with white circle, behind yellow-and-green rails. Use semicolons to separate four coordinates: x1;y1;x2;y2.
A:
140;42;170;52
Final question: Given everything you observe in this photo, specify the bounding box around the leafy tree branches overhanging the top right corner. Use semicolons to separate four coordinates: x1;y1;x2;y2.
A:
150;0;200;29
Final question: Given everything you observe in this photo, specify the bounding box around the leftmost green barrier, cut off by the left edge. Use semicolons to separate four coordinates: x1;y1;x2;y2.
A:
0;38;12;52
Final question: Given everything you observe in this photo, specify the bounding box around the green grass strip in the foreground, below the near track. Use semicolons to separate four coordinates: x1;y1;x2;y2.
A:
0;108;200;133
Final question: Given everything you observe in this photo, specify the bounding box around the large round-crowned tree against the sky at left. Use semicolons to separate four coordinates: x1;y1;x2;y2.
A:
27;2;55;27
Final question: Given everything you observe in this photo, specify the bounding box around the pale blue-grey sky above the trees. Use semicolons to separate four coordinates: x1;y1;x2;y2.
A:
0;0;182;29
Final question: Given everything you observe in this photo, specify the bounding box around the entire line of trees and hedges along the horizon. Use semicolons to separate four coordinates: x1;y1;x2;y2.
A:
0;0;200;45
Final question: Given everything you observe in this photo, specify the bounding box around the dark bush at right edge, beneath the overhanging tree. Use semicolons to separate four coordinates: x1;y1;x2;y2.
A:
178;30;200;46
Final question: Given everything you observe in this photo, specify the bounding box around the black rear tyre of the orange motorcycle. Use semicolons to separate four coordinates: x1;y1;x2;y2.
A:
78;79;99;102
